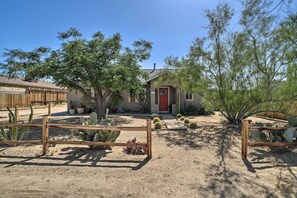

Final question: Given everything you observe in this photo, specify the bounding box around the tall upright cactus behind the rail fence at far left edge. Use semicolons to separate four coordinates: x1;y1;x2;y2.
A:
0;105;33;141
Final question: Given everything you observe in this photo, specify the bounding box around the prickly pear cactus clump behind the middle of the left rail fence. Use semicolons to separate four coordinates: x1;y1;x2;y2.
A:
73;112;120;149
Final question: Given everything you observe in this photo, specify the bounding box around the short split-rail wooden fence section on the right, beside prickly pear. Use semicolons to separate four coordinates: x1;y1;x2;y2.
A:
241;120;297;159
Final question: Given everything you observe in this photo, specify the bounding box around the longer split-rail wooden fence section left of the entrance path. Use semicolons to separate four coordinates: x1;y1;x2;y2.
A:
0;116;152;158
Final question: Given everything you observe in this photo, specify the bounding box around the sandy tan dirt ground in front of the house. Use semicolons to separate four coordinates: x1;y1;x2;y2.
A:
0;104;297;198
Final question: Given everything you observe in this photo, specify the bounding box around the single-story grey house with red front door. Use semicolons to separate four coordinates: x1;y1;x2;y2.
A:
67;66;201;114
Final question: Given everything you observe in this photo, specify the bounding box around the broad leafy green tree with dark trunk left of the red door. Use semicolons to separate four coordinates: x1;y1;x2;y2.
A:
3;28;152;116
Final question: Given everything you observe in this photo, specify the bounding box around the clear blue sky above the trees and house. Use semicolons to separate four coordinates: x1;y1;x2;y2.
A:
0;0;292;68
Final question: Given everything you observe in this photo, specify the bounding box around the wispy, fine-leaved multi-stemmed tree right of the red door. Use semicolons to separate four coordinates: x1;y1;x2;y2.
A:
163;0;297;124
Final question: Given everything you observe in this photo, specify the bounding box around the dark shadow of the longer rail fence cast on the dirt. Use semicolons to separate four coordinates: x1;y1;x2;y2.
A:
0;147;150;170
